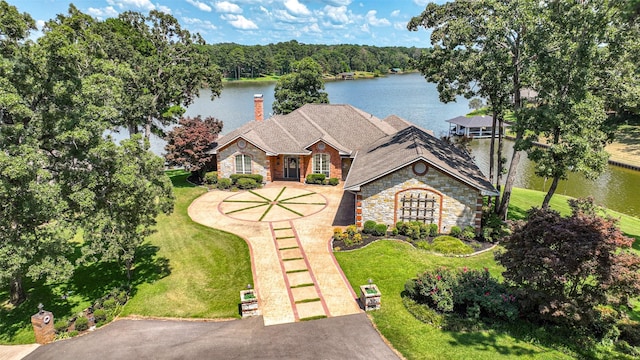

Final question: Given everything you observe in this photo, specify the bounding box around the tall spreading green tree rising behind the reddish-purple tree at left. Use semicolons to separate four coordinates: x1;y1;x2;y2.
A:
97;10;222;138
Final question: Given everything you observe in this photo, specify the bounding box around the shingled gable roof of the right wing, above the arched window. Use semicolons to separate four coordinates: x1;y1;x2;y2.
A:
344;126;498;196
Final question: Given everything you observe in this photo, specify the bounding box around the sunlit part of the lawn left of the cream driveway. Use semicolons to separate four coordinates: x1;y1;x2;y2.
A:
123;173;253;318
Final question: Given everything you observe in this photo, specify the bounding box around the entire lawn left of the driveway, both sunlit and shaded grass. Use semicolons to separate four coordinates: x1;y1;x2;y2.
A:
0;171;253;345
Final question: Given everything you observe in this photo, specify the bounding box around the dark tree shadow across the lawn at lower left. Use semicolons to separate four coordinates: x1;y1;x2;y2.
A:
0;244;171;342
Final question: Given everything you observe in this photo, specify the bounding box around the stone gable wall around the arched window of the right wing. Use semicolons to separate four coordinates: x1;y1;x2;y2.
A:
356;165;482;233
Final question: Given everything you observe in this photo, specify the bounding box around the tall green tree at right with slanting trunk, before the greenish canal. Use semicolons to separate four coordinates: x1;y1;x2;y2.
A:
518;0;624;207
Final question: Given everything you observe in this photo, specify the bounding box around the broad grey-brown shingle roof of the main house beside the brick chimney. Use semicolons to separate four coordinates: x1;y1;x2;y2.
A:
214;104;398;155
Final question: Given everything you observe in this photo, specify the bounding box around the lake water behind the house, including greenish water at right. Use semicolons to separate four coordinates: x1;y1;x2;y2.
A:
126;73;640;217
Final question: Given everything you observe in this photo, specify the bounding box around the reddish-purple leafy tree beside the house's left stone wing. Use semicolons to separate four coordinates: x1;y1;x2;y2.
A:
165;116;222;180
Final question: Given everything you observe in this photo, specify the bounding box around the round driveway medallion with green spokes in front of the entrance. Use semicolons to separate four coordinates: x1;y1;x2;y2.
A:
219;186;327;222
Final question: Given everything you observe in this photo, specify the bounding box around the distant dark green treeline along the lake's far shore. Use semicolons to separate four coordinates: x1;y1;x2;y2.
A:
206;40;425;79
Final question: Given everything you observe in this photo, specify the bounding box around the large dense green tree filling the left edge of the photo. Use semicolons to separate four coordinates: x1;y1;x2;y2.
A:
0;1;122;304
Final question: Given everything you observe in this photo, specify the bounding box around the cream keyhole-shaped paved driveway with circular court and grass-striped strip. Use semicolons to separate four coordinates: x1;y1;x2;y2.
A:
189;182;361;325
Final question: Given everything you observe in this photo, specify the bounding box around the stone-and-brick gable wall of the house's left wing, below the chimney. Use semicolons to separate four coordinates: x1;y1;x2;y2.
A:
218;140;271;181
